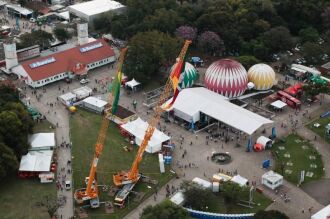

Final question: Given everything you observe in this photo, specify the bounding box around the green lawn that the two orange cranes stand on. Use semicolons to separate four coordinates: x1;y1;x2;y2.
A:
70;108;173;218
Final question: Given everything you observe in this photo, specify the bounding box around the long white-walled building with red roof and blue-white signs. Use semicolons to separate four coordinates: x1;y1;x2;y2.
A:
12;39;116;88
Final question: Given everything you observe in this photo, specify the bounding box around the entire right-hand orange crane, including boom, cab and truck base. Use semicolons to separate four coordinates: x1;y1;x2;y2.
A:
113;40;191;207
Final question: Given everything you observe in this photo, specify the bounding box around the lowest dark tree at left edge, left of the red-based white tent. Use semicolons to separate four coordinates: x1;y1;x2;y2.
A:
0;141;18;179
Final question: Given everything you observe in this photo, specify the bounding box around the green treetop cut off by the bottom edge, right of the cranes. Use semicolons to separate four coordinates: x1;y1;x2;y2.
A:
141;201;191;219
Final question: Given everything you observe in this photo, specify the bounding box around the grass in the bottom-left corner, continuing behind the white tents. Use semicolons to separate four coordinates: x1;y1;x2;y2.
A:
0;121;56;219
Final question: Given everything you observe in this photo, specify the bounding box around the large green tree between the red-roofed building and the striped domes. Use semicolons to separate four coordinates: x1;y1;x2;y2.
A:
123;31;182;83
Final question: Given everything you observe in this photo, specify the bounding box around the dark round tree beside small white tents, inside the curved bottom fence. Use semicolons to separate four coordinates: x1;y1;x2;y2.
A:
183;185;213;210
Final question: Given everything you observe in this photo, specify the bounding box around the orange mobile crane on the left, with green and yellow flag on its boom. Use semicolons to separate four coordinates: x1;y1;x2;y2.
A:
74;48;127;208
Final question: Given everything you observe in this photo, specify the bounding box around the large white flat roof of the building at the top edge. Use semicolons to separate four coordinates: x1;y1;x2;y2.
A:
68;0;125;16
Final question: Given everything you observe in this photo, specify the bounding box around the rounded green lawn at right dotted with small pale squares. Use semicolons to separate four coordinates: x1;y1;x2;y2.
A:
272;134;324;184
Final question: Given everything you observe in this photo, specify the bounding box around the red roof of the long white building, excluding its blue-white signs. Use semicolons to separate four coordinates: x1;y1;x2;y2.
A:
22;39;115;81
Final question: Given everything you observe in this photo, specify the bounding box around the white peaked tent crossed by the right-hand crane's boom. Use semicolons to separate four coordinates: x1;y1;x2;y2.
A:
121;118;170;153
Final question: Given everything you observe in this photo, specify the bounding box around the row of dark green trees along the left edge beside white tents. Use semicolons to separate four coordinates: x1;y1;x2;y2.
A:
0;84;33;179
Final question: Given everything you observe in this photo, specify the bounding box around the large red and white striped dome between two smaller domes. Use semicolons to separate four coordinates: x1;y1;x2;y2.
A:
204;59;248;98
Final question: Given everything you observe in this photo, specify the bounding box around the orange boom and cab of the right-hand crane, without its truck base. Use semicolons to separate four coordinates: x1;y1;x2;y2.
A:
113;40;191;186
